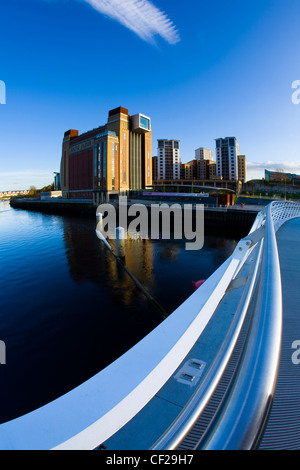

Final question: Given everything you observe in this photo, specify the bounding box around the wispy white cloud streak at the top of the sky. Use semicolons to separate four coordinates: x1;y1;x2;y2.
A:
83;0;180;44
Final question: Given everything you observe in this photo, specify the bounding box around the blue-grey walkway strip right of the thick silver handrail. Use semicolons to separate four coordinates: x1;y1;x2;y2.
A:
260;217;300;450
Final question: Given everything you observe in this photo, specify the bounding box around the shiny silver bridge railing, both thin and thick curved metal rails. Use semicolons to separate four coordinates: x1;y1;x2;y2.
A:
153;202;300;450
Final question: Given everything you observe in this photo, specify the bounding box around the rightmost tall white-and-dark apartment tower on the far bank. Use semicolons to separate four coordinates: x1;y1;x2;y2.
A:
216;137;240;181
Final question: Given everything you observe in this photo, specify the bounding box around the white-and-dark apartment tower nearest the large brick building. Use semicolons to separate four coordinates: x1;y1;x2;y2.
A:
157;139;180;180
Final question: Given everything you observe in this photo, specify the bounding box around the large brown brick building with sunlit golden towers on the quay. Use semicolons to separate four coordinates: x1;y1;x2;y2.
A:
60;107;152;203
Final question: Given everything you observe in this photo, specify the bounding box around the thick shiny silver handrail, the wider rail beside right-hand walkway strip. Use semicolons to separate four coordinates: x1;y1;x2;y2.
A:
200;203;287;450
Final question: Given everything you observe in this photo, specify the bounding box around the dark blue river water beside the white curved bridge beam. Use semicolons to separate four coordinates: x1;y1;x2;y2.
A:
0;203;236;422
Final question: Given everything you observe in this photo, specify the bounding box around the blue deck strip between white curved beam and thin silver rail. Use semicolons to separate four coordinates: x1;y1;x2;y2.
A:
104;241;256;450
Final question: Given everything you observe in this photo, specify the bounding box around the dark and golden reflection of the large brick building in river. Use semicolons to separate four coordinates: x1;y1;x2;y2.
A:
64;220;154;307
